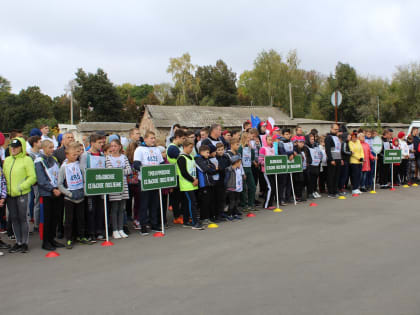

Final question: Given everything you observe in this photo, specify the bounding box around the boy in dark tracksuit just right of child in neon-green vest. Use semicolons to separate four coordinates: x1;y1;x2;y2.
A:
195;145;218;224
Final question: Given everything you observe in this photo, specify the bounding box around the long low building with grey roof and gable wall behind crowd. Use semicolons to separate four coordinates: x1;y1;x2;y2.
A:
140;105;332;141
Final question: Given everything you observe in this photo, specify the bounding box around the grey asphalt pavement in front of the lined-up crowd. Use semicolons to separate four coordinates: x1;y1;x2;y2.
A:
0;187;420;315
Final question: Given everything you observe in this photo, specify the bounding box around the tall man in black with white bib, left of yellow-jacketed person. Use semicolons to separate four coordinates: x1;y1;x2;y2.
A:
325;124;343;198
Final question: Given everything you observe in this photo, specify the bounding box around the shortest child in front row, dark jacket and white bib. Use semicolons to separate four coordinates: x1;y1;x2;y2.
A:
225;155;243;221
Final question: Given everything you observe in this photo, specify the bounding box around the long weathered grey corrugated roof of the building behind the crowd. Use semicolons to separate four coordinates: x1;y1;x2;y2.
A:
146;105;331;128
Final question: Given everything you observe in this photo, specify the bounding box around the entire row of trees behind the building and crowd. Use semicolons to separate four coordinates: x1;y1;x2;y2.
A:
0;49;420;131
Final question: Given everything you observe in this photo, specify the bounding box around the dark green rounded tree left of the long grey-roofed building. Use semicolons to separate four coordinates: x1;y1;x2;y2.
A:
74;69;123;121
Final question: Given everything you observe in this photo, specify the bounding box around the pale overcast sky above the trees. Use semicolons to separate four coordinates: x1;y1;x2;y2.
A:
0;0;420;97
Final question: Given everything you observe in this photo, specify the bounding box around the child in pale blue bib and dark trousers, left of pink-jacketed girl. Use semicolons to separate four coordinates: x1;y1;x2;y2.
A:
239;132;256;211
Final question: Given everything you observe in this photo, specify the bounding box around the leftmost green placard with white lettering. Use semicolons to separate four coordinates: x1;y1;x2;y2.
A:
85;168;124;196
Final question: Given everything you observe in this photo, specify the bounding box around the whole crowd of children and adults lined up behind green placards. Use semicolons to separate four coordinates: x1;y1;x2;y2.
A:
0;121;420;255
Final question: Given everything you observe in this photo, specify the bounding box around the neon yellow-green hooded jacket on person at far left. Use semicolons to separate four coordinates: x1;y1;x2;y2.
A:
3;137;36;197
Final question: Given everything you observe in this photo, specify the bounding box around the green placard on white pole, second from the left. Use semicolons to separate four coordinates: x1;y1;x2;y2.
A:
141;164;177;191
